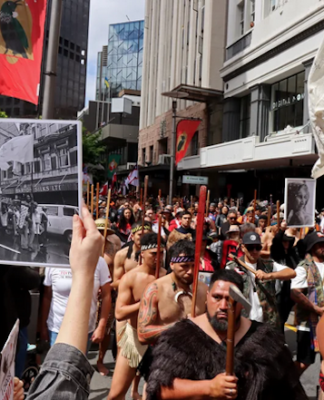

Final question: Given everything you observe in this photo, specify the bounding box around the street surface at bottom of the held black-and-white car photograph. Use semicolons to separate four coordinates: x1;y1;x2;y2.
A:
0;234;70;264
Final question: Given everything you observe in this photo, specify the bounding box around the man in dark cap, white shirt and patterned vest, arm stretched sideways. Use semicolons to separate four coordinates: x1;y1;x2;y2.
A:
226;232;296;328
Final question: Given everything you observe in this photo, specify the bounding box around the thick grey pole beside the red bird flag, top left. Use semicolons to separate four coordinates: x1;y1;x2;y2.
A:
42;0;63;119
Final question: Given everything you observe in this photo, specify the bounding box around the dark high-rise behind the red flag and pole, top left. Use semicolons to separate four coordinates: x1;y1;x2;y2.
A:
0;0;90;119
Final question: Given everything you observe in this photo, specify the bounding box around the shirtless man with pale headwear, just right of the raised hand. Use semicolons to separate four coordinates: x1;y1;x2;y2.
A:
95;218;121;376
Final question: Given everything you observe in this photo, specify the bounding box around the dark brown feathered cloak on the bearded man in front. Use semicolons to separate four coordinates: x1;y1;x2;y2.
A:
147;320;307;400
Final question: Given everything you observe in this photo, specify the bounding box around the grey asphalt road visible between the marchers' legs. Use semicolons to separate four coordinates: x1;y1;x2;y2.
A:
89;324;320;400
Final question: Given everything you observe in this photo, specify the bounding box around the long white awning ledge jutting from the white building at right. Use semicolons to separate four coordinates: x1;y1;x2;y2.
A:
178;132;318;170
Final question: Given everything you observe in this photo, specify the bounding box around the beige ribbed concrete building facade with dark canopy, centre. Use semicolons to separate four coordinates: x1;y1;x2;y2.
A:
139;0;227;194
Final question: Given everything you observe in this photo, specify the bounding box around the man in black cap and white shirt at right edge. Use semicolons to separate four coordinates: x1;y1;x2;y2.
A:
291;232;324;374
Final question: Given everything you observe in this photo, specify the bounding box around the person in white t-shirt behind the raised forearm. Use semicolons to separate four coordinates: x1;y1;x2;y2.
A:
41;257;111;354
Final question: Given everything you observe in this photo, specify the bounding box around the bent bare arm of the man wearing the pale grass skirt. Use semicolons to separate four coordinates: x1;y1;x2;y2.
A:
115;274;140;321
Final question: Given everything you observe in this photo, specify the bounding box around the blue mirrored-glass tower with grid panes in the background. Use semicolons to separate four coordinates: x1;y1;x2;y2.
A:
96;21;144;101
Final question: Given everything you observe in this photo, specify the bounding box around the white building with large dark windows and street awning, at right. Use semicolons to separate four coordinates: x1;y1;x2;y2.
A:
200;0;324;201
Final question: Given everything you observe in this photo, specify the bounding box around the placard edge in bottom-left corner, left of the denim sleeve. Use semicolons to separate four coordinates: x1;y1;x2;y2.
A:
0;320;19;400
